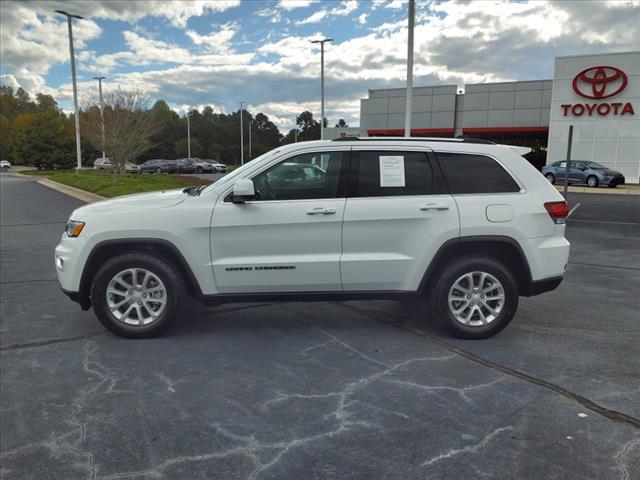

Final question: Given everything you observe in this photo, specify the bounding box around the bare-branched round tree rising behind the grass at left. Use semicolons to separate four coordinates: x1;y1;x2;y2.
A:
81;88;161;182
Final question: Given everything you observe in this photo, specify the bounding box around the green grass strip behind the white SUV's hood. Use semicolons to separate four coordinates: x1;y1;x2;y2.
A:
20;170;210;197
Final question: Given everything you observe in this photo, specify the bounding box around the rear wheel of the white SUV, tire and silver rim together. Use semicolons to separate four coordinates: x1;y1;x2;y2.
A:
433;257;518;339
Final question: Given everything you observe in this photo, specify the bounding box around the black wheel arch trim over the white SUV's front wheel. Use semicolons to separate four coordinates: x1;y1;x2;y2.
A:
78;238;202;310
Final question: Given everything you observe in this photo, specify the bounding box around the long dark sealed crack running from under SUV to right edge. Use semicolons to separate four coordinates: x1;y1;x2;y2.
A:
332;302;640;429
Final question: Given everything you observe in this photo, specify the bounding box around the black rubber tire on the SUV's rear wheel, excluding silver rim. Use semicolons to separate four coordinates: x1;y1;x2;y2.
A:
431;256;518;339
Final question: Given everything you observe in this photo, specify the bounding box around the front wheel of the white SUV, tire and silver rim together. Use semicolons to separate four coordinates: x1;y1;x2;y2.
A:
91;252;185;338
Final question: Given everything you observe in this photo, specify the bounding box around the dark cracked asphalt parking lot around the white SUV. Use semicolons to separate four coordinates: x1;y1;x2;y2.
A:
0;174;640;479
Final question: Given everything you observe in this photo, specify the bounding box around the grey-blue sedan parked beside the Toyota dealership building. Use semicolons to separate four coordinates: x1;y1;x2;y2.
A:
542;160;625;188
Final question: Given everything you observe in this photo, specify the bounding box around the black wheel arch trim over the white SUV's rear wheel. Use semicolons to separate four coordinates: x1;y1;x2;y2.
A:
418;235;533;297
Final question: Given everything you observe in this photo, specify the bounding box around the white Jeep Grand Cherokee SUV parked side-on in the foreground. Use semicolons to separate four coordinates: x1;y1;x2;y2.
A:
55;137;569;338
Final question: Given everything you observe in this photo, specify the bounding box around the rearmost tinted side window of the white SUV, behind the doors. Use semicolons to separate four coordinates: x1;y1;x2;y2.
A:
436;152;520;195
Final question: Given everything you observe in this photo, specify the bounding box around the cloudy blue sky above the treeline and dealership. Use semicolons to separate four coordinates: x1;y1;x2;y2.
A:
1;0;640;129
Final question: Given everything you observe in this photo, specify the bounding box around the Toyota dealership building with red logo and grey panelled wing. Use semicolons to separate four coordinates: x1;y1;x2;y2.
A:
360;52;640;183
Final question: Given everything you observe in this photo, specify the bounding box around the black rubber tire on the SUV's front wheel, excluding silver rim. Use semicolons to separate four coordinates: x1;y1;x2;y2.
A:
91;252;186;338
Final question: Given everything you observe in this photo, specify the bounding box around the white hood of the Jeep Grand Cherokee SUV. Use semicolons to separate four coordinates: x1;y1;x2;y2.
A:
71;188;189;220
